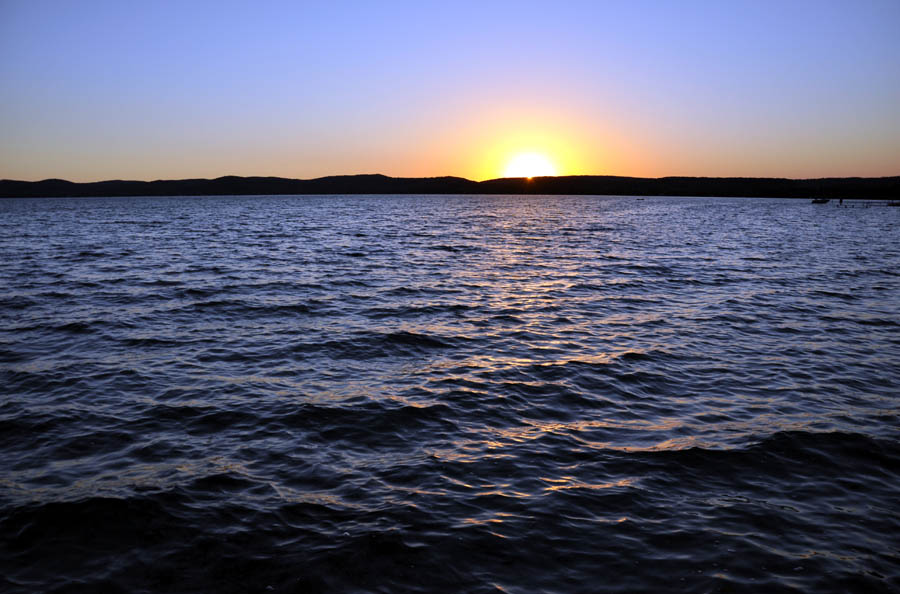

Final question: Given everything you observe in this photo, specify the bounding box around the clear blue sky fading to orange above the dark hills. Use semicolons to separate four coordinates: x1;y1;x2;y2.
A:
0;0;900;181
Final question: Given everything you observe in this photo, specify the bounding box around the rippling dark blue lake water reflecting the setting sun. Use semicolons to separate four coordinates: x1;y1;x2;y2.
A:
0;196;900;593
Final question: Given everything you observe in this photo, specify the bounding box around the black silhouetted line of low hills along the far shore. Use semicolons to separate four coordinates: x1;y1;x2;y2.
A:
0;174;900;200
